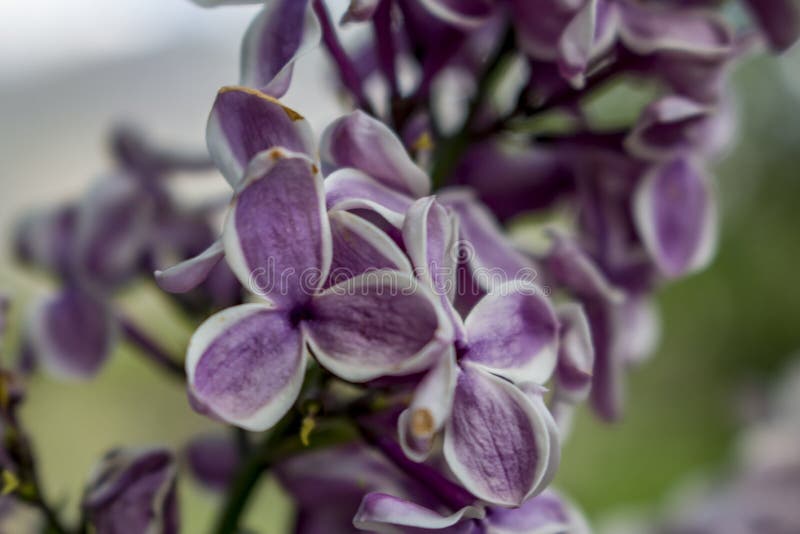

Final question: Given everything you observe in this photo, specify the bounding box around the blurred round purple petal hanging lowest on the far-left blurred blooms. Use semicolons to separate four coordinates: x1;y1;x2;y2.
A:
27;286;115;380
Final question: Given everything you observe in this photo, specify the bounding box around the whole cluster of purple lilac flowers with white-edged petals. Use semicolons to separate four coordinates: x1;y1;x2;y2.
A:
0;0;800;534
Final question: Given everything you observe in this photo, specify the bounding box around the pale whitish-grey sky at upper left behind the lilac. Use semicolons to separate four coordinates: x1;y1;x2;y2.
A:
0;0;354;253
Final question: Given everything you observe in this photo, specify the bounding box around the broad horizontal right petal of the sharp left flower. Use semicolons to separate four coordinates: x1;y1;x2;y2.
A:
303;270;453;382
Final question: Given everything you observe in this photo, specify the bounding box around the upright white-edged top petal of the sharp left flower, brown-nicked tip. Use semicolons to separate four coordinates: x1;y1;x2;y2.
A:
222;153;331;307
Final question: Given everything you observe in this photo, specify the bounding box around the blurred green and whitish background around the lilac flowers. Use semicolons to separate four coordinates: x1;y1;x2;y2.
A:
0;0;800;533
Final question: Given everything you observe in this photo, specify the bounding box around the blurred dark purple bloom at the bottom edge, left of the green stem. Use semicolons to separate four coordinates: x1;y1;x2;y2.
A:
83;449;179;534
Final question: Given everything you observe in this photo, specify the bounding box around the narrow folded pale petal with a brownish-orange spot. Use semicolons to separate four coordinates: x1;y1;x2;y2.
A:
397;347;456;462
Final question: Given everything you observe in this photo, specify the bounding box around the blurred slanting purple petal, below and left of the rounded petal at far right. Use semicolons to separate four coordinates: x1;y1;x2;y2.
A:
546;231;624;302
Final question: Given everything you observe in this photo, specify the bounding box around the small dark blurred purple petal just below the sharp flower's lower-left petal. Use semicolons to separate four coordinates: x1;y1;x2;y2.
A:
185;434;241;491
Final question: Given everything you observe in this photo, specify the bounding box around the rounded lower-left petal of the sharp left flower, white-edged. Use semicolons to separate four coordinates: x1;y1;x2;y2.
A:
186;304;307;431
